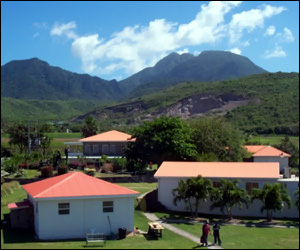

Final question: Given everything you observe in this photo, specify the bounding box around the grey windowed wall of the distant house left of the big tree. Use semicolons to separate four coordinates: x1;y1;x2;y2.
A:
83;142;127;156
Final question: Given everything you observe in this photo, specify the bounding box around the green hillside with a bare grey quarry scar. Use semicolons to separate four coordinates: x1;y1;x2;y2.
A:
70;72;299;135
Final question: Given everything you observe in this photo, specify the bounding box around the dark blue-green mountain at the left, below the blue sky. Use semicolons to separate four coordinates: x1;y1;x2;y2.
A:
1;58;122;101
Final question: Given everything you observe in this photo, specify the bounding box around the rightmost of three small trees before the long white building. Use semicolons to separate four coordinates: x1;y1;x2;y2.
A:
251;183;292;221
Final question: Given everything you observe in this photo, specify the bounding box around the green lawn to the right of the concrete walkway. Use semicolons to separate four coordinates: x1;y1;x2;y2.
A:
156;213;299;249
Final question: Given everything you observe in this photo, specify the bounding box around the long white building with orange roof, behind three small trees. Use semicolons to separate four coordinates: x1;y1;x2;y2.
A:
154;162;299;218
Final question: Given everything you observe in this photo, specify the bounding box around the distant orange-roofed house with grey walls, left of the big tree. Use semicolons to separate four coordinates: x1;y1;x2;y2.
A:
79;130;135;156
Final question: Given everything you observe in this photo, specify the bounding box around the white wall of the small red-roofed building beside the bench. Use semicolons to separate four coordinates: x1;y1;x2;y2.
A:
36;198;134;239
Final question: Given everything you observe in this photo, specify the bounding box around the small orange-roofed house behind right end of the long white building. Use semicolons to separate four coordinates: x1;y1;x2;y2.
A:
244;145;291;173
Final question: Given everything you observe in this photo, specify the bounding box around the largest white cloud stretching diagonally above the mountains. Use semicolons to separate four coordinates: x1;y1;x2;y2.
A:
50;1;287;76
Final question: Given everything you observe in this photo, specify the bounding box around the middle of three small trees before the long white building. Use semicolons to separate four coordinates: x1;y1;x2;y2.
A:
210;179;250;220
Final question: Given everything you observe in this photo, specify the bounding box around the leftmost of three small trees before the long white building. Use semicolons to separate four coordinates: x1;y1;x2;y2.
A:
173;176;212;217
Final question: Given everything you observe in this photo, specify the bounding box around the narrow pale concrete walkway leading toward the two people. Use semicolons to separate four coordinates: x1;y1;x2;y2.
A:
144;213;222;249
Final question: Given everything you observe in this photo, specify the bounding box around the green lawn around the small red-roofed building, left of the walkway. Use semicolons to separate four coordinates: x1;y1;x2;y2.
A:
1;183;197;249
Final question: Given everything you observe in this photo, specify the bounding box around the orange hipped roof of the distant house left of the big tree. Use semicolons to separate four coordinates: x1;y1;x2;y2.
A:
78;130;135;142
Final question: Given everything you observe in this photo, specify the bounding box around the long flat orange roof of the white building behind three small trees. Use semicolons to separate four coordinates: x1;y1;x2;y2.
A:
154;161;279;179
